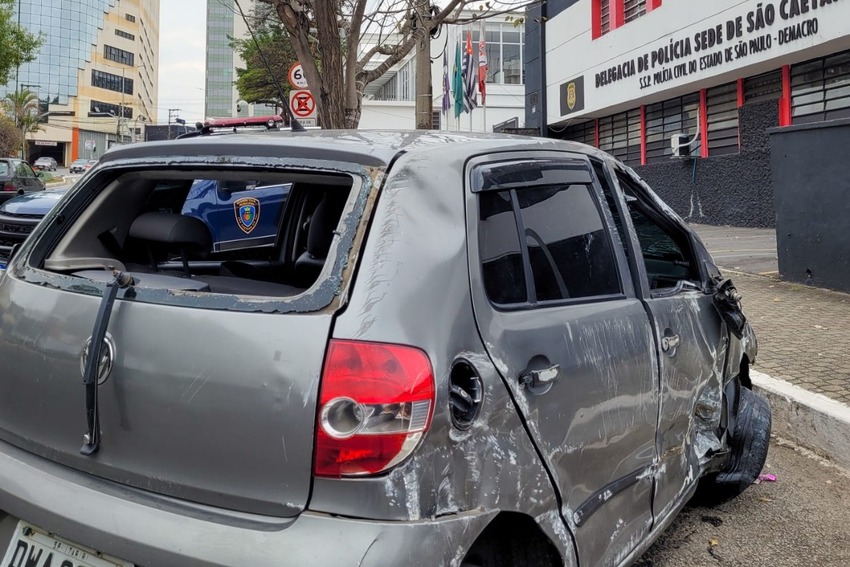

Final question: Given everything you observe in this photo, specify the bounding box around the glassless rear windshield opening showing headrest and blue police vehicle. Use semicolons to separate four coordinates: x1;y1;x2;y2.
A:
41;170;355;298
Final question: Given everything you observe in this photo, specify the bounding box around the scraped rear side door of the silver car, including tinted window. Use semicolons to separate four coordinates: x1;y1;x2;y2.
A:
467;153;657;565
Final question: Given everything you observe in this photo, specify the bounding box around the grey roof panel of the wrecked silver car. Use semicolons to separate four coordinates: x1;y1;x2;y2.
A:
100;130;599;166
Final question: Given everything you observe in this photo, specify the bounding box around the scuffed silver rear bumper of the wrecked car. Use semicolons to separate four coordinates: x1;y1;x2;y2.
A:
0;442;490;567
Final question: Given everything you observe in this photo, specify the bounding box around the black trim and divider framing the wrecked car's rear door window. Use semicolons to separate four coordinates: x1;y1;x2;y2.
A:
464;150;634;311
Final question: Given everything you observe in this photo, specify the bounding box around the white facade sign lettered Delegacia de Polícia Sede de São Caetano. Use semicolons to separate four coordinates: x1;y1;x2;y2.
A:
547;0;850;121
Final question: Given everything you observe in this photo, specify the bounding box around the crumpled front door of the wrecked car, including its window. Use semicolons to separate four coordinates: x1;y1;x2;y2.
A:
615;167;728;520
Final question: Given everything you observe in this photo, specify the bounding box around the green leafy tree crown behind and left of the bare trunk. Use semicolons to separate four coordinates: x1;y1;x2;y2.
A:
232;13;298;110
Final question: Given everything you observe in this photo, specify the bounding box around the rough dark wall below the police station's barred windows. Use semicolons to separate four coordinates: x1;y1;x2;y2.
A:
634;101;779;228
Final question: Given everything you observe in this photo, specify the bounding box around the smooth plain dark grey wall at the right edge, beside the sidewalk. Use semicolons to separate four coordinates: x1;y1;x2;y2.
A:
770;120;850;292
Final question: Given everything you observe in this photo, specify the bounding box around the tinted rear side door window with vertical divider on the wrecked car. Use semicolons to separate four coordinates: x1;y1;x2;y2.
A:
477;160;622;305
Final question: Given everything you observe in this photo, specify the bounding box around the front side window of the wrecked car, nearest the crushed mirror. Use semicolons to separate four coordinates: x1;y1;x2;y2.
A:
617;171;700;290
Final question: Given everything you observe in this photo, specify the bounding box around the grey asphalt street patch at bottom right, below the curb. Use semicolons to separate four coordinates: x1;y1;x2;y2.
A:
636;441;850;567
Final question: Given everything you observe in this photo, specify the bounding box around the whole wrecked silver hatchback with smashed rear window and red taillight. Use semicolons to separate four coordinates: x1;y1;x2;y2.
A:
0;131;770;567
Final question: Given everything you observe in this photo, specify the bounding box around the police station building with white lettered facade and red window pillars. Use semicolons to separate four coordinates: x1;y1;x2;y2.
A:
525;0;850;227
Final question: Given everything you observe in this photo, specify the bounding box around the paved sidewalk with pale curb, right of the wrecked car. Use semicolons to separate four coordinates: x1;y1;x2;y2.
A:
693;225;850;468
